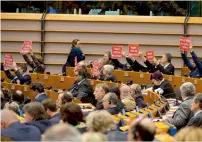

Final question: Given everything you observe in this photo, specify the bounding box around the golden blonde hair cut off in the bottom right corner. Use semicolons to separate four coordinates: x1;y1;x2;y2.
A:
174;127;202;141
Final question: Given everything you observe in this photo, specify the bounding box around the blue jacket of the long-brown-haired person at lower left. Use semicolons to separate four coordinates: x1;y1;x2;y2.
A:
25;120;52;134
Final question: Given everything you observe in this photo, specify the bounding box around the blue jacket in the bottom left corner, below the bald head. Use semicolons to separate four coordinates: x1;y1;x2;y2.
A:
1;121;41;141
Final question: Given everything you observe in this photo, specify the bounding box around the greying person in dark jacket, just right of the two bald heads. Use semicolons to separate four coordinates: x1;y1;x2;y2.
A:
130;84;147;108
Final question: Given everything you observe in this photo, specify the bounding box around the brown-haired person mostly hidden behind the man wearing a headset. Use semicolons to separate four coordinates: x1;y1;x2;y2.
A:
109;85;124;112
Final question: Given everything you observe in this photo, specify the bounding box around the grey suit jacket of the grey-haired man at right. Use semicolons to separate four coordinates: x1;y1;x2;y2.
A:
166;97;194;129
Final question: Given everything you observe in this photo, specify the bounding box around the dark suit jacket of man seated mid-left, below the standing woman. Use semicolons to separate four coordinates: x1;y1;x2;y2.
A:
68;79;95;105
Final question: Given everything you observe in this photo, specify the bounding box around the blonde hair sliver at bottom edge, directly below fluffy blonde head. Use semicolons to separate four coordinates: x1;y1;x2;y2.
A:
82;132;107;142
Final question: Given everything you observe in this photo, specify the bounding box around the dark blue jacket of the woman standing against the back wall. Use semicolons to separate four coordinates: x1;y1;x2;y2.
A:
67;47;85;67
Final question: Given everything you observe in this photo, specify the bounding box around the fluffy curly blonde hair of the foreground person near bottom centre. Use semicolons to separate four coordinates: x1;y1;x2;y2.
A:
86;110;115;133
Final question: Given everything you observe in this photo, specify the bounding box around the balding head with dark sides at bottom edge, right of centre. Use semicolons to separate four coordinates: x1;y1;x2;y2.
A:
128;118;156;141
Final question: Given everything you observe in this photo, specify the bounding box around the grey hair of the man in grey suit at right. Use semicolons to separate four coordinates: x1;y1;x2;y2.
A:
180;82;196;97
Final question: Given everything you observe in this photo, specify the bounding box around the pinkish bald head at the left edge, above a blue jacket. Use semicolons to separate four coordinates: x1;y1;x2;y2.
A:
0;109;18;128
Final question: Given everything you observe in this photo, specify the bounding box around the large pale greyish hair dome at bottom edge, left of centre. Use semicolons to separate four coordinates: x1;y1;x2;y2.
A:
43;123;82;142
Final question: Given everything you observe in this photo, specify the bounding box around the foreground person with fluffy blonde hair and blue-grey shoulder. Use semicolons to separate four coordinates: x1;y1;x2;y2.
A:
86;110;127;141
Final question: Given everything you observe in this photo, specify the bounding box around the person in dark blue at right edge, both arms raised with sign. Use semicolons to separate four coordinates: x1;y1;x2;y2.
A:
181;46;202;78
